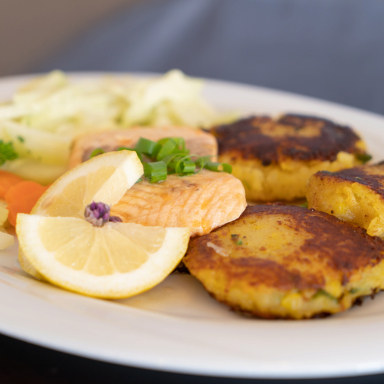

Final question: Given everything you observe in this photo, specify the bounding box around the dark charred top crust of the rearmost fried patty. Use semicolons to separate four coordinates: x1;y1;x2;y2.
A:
211;114;365;166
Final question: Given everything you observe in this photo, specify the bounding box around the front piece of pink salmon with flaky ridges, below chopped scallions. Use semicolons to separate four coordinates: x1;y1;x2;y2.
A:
111;170;246;236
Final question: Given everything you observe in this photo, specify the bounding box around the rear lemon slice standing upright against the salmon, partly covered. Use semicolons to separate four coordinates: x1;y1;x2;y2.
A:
19;151;144;280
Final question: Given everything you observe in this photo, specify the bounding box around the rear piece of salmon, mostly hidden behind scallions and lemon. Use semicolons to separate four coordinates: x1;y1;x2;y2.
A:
69;127;217;168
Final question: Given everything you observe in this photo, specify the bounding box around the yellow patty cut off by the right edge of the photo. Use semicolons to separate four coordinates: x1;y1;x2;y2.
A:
307;163;384;237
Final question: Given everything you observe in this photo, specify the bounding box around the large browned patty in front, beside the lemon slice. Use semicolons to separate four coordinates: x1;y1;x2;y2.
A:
183;203;384;319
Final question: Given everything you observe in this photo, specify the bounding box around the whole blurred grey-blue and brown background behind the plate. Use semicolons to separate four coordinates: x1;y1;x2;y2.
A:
0;0;384;114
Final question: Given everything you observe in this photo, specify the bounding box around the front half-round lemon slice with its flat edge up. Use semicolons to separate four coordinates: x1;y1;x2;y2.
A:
16;214;189;299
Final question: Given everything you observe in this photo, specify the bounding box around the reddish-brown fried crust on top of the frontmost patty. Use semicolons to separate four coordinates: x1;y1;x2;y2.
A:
184;204;384;291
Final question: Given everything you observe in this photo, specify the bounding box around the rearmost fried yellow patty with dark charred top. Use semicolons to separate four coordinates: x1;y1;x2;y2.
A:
211;114;366;202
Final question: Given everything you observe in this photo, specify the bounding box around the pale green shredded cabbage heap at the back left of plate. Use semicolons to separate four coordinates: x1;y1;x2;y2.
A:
0;70;228;184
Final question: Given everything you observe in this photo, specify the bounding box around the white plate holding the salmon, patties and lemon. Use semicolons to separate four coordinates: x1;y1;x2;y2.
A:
0;74;384;378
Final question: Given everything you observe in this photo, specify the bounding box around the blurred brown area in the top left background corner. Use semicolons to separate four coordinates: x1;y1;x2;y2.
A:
0;0;139;76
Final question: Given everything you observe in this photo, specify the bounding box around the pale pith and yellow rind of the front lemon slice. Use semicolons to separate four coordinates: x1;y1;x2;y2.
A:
17;214;189;299
